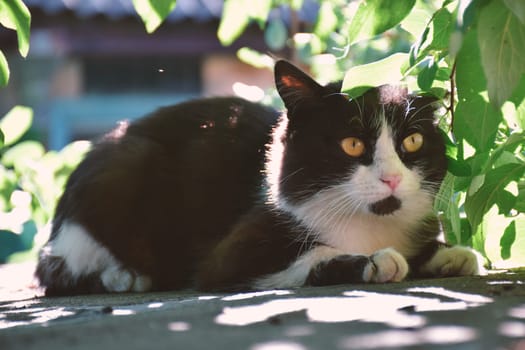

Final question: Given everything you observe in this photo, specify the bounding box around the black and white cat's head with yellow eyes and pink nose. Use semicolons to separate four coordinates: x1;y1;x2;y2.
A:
267;61;446;226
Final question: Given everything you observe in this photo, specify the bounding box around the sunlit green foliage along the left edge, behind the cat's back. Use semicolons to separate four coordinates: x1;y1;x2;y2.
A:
0;0;89;263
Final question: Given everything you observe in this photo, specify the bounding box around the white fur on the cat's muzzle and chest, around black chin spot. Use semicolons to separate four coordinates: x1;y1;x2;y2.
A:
282;123;433;257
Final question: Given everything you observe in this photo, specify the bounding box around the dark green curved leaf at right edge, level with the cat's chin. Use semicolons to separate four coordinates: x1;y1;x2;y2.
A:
465;164;525;231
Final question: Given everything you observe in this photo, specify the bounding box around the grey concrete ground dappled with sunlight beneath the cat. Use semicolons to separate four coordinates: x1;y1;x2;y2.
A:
0;264;525;350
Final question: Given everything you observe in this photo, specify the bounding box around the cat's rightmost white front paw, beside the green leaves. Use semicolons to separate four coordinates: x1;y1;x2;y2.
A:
421;246;483;277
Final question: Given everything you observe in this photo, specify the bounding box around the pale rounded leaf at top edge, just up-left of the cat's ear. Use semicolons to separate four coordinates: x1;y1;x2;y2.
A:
217;0;250;46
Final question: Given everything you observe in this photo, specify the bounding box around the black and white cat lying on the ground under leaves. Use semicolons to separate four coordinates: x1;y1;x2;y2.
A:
36;61;478;295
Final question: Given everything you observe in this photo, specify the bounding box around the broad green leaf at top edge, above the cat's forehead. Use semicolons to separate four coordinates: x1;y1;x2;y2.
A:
348;0;416;44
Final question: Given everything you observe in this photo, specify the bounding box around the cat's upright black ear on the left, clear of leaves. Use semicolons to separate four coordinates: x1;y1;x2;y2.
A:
274;60;324;110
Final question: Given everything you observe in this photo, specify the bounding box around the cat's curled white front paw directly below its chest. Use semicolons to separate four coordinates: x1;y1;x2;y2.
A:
363;248;408;283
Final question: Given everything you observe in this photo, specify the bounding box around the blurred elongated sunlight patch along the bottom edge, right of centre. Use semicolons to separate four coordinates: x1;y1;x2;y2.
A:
340;326;478;349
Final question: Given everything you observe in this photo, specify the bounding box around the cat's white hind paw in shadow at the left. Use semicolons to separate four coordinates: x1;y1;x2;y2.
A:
100;266;152;292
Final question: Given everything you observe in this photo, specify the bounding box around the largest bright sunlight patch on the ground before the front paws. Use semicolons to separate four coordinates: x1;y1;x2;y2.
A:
215;287;493;328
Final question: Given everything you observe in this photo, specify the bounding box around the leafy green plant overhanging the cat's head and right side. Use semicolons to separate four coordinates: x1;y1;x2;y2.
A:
135;0;525;267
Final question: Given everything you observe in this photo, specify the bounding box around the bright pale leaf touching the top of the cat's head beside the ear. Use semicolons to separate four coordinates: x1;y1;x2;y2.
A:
342;53;409;98
